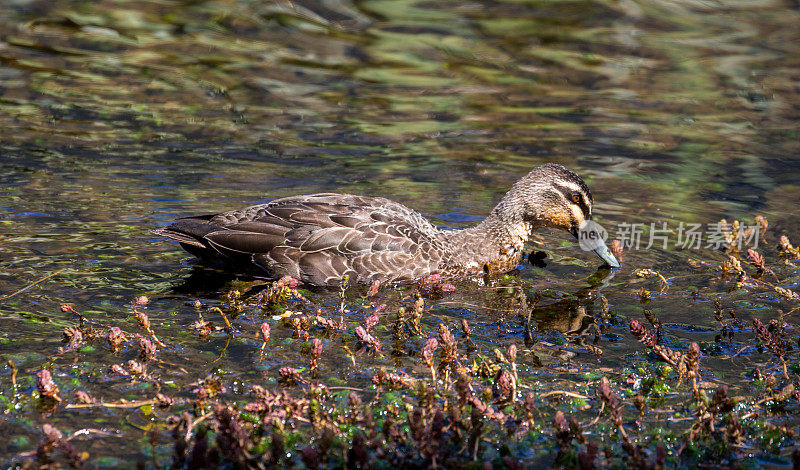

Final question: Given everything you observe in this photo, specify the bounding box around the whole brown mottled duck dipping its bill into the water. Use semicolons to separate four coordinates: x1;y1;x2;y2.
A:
154;163;619;286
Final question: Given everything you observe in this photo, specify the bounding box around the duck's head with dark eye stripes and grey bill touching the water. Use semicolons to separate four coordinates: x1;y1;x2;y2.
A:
495;163;619;268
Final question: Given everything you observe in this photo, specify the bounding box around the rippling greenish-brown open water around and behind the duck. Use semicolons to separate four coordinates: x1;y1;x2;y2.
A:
0;0;800;465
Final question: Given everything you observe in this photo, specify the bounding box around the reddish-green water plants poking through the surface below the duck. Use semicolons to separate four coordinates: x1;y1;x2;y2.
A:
6;218;800;469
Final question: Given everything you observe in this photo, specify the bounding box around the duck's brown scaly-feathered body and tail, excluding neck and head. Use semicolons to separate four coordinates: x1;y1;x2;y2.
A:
156;193;444;285
